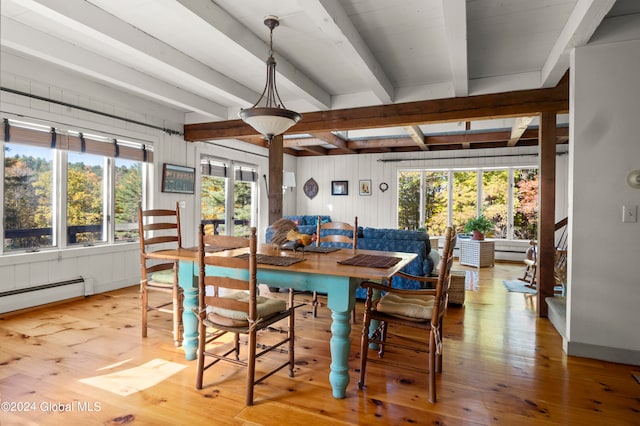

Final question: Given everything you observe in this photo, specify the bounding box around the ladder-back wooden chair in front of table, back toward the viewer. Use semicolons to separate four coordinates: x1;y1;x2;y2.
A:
196;225;295;405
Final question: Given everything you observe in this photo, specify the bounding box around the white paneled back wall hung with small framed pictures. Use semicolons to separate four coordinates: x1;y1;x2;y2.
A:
296;146;568;261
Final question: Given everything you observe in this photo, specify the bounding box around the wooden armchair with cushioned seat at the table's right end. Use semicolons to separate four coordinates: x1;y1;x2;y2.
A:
358;227;456;403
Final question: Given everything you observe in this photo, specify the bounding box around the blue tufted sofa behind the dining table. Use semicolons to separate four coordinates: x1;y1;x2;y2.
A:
265;216;437;299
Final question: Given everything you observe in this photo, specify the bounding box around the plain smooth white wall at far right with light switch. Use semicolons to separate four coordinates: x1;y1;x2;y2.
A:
564;40;640;364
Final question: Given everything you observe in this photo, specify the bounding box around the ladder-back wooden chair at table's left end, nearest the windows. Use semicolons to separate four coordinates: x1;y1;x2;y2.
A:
138;203;183;346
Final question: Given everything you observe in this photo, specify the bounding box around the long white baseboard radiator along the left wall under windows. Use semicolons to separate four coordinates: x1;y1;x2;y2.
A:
0;277;85;314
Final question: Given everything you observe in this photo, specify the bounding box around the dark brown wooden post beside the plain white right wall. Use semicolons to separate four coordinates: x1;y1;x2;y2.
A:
537;112;556;318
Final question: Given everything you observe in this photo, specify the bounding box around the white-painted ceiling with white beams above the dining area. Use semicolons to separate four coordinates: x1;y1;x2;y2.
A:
0;0;640;146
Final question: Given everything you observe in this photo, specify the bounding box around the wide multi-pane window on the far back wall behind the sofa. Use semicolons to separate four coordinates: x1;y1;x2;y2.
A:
398;167;538;240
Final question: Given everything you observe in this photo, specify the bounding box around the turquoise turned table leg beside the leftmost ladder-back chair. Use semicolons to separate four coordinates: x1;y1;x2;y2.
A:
178;262;198;361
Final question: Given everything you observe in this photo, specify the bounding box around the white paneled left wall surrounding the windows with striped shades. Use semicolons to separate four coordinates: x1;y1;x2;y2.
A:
0;49;190;312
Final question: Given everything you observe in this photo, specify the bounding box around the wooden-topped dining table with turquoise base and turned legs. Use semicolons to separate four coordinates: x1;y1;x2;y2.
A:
145;244;416;399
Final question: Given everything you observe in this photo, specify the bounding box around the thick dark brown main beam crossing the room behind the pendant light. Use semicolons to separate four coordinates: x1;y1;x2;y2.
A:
184;79;569;142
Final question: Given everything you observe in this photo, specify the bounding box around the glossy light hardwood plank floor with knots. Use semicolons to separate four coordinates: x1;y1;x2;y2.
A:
0;263;640;426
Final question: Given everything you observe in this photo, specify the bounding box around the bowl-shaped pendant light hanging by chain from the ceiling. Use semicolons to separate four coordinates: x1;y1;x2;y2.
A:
239;16;302;142
